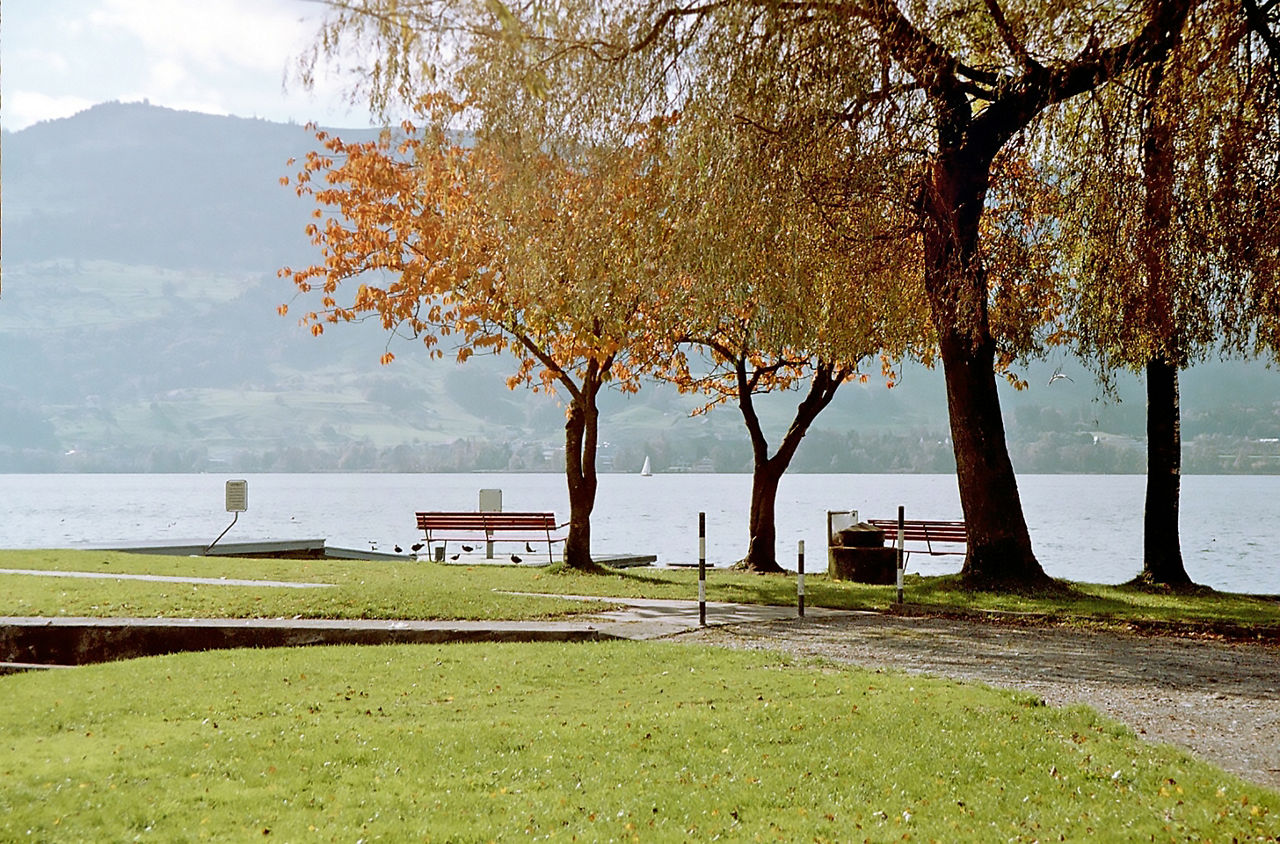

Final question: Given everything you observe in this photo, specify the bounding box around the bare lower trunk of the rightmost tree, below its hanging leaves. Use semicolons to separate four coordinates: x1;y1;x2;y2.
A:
1138;360;1192;587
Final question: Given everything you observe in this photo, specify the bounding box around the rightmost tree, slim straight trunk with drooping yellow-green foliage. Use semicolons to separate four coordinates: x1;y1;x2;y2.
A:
1046;0;1280;588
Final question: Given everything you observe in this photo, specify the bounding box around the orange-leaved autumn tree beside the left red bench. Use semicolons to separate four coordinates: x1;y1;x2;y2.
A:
282;107;662;570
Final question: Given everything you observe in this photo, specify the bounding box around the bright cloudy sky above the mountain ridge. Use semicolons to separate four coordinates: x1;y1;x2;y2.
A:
0;0;369;131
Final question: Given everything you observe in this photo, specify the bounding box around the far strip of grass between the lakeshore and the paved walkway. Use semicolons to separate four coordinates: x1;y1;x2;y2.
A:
0;551;1280;640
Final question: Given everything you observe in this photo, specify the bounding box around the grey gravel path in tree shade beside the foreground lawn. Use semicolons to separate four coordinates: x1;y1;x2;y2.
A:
681;613;1280;790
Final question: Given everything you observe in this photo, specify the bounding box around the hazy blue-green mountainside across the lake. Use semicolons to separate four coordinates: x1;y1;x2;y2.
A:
0;102;1280;471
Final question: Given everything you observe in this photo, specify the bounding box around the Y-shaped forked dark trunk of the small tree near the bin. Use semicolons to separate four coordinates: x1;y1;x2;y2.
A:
735;359;846;574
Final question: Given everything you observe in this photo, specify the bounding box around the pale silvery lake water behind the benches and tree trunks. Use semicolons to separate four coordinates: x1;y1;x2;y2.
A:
0;474;1280;594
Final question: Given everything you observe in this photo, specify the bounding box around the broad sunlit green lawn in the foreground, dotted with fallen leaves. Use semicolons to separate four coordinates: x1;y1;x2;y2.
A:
0;643;1280;841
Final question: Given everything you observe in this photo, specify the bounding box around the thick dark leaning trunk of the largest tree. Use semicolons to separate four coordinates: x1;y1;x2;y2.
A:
924;150;1052;590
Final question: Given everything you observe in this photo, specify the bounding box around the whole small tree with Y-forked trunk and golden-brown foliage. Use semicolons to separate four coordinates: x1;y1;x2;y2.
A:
648;102;928;572
